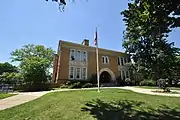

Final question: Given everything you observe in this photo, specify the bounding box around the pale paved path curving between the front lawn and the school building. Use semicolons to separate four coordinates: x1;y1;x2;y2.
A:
0;87;180;110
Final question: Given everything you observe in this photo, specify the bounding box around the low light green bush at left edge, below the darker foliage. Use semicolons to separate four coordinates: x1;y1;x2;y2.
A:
0;72;23;84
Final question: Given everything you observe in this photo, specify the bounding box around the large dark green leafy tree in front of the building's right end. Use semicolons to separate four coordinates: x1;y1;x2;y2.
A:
121;0;180;80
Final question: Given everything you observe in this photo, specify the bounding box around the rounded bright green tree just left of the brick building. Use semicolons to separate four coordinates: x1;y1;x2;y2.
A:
11;44;54;85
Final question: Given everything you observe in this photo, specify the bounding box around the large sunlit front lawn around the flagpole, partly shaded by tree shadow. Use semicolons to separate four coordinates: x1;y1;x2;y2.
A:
0;89;180;120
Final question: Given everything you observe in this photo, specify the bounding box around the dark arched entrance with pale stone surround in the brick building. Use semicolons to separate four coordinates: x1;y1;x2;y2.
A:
99;68;116;83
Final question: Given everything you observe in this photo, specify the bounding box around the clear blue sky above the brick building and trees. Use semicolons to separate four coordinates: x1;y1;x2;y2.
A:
0;0;180;62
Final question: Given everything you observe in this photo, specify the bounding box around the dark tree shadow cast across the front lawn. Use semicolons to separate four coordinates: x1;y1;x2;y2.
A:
81;99;180;120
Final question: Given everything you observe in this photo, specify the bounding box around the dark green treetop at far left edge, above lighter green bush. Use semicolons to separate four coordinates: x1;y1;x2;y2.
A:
0;62;18;75
